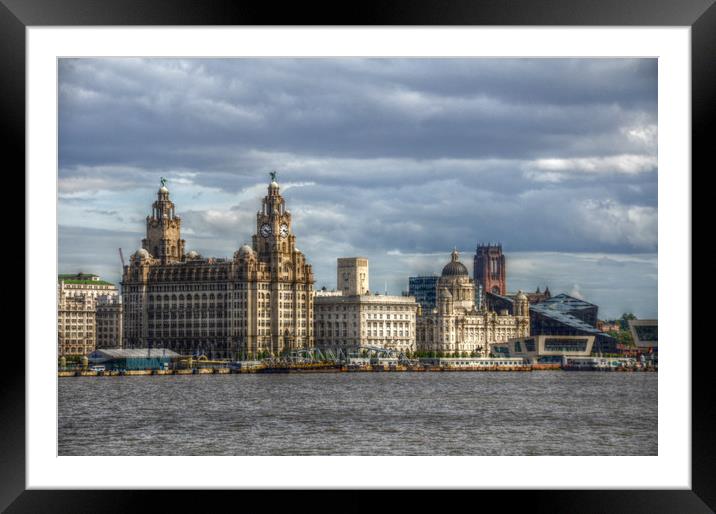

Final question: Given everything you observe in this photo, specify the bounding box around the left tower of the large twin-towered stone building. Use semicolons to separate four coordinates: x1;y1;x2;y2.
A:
142;177;184;264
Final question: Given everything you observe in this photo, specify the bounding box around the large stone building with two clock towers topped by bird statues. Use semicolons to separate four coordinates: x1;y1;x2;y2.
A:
122;173;314;359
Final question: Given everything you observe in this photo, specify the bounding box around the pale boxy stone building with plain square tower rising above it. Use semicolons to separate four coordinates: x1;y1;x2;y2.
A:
315;257;418;352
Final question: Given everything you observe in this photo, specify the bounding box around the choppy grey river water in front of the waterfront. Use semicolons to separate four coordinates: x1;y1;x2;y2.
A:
58;371;658;455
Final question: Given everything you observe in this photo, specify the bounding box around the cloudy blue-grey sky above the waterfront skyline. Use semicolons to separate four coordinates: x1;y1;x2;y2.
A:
58;58;658;319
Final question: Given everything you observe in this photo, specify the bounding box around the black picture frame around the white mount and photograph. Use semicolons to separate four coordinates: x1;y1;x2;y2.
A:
0;0;716;512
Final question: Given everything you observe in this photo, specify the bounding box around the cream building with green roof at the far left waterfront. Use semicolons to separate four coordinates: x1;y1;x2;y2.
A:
57;273;118;355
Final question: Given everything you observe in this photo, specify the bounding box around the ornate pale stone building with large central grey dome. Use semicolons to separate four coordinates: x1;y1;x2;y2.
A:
417;250;529;356
